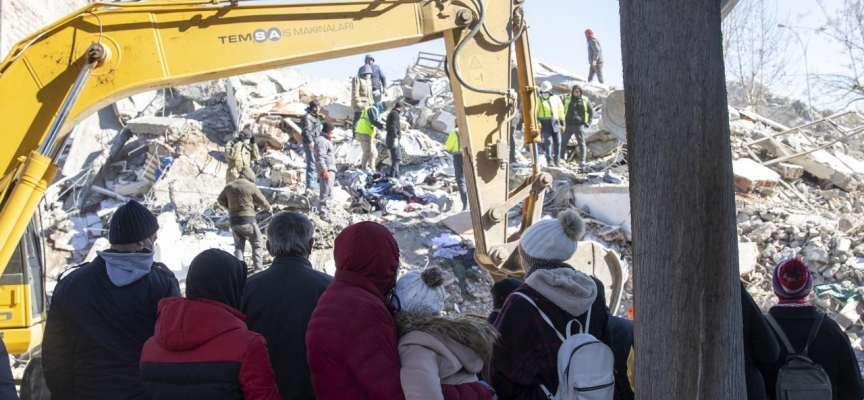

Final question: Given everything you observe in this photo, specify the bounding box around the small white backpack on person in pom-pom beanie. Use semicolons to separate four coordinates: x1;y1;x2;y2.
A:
513;292;615;400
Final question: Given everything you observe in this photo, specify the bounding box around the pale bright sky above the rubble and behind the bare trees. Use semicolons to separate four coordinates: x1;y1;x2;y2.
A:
262;0;843;107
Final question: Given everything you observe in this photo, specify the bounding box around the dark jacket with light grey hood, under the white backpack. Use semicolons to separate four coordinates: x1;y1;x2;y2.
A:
483;264;612;400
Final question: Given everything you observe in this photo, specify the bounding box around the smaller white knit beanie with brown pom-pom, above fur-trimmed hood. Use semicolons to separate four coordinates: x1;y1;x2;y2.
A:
396;267;447;316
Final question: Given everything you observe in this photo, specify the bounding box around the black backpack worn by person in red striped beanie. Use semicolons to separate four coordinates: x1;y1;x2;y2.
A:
765;313;833;400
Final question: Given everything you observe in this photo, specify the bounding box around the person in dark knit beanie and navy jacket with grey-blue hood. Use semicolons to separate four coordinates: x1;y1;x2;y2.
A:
42;200;180;400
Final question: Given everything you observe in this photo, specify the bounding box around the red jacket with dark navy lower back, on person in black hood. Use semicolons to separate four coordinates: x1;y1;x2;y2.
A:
141;297;279;400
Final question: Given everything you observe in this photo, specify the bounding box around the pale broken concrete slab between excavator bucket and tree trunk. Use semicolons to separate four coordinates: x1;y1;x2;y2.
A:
571;183;633;240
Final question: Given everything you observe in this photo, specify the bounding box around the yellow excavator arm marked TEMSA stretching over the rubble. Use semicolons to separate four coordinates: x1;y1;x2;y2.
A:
0;0;551;284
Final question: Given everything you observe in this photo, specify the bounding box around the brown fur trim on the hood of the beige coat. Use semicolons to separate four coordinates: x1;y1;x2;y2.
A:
395;312;501;360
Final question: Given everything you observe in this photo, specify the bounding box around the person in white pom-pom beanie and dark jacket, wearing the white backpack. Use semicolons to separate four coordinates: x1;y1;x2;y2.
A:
483;210;613;400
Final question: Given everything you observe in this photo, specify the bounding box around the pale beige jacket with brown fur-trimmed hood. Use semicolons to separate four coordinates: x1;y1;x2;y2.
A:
396;312;498;400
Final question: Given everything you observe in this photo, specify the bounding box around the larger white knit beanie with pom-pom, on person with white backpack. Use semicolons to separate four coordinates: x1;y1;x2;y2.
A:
519;210;585;261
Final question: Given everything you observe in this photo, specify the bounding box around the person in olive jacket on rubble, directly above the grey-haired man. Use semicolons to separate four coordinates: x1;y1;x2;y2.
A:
217;167;270;270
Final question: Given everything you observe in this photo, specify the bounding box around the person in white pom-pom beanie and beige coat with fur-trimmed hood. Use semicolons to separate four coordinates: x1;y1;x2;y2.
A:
395;267;498;400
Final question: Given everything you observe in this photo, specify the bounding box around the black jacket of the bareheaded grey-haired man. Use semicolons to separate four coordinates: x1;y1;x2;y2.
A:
243;252;333;400
